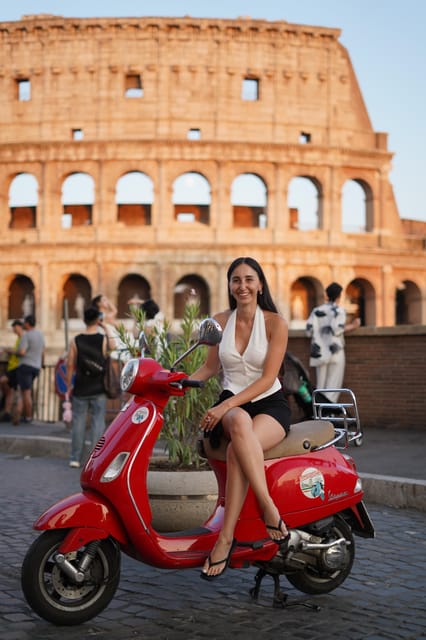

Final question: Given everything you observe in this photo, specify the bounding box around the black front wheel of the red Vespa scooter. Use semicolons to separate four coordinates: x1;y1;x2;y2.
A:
21;529;120;625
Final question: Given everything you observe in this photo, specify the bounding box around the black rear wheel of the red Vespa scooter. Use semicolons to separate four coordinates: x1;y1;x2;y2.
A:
286;516;355;595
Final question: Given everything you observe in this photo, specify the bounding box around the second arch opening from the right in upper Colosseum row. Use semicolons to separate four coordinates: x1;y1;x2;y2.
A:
287;175;323;231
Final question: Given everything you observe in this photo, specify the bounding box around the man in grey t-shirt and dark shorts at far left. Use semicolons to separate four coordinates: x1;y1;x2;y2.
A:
16;314;45;423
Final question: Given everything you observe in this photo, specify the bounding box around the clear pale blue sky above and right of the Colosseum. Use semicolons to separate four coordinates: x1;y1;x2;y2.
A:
0;0;426;221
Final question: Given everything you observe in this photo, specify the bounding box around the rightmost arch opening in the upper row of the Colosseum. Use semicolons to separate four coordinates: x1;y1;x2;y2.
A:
342;178;373;233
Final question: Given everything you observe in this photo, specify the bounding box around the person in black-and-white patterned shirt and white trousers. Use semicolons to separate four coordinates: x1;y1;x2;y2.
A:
306;282;361;402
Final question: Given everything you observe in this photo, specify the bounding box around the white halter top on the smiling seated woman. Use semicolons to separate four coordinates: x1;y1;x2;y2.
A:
219;306;281;402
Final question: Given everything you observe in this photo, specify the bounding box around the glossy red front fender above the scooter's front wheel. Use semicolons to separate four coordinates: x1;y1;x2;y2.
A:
33;491;129;545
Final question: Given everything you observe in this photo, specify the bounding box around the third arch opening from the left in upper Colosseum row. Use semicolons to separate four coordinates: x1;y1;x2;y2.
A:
115;171;154;226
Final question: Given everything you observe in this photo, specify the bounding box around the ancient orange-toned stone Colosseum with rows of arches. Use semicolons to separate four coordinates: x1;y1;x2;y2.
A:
0;14;426;351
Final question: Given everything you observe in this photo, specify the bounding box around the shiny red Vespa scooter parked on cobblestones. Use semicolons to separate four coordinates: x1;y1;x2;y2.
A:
21;318;374;625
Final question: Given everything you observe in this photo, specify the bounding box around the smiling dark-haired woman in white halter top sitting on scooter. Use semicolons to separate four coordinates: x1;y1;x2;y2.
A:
191;258;290;580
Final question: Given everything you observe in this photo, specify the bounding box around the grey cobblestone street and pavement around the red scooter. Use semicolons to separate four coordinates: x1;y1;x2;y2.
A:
0;423;426;640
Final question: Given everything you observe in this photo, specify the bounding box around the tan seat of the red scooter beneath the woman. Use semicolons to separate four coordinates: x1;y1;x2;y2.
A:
199;420;334;460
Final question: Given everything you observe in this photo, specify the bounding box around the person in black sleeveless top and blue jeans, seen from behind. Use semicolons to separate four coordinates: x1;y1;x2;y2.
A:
66;307;114;468
